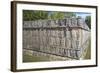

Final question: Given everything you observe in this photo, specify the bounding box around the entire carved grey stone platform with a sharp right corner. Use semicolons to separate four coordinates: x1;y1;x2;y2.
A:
23;18;90;60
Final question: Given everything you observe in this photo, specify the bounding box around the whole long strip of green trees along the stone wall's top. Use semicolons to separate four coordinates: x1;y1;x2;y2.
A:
23;10;76;21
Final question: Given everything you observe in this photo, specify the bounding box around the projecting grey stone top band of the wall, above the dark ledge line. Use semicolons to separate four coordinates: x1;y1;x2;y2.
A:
23;18;89;30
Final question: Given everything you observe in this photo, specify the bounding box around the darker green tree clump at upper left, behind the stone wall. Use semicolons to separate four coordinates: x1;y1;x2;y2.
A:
23;10;48;21
